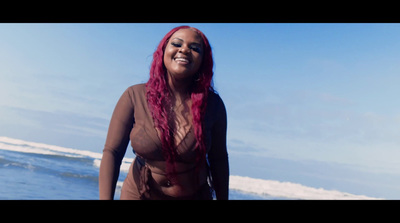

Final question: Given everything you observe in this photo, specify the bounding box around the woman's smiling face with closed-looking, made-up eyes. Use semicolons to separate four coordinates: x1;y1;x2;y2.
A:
164;29;203;80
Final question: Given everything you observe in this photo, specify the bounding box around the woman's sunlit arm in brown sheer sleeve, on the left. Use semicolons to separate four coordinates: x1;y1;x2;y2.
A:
99;88;134;200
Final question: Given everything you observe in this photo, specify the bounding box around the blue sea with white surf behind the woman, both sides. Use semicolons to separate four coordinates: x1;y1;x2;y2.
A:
0;137;380;200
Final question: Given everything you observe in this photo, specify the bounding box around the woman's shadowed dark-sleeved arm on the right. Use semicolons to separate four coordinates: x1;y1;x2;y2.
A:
208;97;229;200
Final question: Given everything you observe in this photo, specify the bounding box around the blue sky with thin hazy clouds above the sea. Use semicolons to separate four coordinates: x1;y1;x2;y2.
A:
0;23;400;198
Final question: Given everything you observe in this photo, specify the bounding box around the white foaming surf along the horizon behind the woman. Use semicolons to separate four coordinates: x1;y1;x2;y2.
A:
0;137;382;200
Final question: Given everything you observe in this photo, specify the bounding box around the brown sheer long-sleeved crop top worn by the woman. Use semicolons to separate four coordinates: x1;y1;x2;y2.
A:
99;84;229;199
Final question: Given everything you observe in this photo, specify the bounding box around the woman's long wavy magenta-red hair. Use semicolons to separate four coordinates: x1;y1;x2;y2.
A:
146;26;214;183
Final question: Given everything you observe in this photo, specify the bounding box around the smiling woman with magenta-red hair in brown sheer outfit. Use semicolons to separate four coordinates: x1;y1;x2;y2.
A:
99;26;229;200
